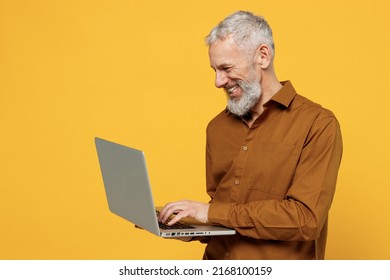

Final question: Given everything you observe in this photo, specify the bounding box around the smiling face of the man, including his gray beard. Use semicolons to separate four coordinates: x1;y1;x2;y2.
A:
209;37;261;116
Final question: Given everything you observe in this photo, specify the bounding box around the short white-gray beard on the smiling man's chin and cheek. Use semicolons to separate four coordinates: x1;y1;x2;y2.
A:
227;80;261;117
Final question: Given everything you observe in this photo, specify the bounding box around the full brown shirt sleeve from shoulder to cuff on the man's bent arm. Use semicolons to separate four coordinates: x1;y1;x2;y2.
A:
207;114;342;241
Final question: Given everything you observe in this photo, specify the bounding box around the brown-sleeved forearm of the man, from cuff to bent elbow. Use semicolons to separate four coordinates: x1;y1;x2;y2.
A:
209;200;322;241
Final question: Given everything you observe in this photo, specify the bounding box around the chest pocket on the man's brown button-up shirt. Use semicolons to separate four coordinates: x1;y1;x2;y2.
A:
247;143;300;200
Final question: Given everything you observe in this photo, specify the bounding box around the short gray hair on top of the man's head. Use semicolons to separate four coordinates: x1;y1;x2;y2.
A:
205;11;275;56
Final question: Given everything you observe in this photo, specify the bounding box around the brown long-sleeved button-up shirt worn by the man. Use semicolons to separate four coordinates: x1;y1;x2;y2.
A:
204;82;342;259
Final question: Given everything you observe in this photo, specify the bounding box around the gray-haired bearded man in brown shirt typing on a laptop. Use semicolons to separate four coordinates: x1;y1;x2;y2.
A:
159;11;342;259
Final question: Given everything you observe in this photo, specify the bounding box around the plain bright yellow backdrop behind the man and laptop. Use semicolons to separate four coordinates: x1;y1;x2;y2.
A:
0;0;390;259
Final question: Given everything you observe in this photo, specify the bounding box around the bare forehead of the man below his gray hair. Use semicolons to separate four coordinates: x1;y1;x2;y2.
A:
209;37;244;69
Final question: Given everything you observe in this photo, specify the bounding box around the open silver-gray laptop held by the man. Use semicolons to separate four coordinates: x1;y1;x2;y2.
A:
95;137;236;238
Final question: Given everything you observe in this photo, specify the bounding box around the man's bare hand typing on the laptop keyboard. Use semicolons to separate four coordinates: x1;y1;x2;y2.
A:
158;200;210;225
